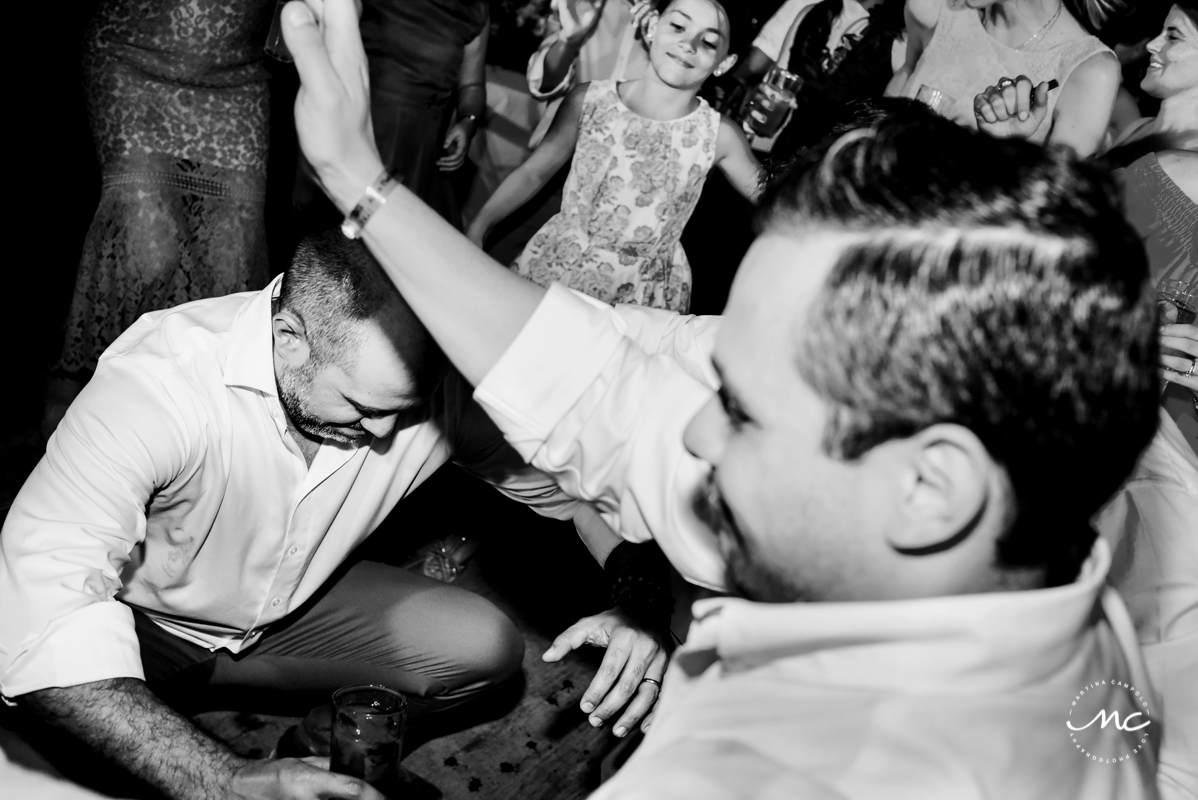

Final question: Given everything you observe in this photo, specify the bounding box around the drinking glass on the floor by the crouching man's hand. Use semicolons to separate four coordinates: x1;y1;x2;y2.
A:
329;684;407;792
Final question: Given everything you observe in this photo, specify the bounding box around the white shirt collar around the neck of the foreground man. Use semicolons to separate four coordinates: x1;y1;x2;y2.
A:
676;539;1111;692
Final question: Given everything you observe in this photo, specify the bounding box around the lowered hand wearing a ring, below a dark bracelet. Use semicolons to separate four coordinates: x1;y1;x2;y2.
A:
541;608;670;737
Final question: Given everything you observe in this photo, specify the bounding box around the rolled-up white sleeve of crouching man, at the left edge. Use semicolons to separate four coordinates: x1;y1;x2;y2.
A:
0;358;188;697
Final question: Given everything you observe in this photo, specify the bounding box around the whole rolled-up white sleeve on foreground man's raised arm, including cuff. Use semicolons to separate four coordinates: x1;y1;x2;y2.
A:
474;285;724;589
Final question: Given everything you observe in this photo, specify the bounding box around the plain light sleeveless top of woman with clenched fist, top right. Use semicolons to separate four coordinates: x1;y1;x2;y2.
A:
902;0;1114;144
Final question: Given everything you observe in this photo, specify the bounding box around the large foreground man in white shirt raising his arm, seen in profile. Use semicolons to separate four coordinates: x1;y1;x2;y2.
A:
284;0;1160;800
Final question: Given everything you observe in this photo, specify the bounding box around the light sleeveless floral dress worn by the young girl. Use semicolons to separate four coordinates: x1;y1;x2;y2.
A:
512;80;720;311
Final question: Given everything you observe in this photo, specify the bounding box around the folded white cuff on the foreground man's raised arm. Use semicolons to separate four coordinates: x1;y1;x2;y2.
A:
474;284;624;461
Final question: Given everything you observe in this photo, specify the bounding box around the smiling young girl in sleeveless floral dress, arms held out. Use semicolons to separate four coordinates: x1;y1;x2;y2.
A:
467;0;761;311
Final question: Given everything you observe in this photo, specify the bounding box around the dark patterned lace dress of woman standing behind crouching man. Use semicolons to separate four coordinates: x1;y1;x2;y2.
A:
55;0;274;378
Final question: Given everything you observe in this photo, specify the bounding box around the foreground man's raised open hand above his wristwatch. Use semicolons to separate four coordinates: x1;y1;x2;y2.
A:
283;0;382;211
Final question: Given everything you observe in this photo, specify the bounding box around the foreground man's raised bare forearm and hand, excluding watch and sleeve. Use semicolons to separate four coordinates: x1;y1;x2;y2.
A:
284;0;545;384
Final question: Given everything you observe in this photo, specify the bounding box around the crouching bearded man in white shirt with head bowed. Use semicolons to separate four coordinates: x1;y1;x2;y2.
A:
0;231;664;798
